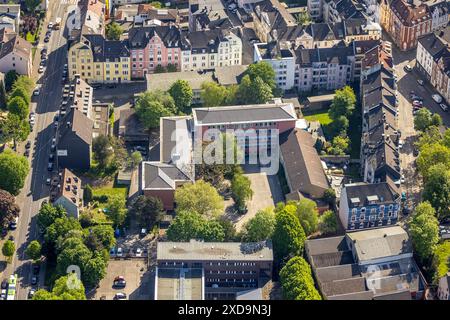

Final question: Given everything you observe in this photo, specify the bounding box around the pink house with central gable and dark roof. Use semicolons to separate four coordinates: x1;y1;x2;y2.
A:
128;26;181;79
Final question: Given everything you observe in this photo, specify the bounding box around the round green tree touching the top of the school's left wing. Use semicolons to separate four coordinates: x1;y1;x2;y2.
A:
136;90;176;129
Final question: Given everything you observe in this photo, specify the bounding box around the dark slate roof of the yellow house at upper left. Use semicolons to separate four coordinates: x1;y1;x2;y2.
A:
83;34;130;62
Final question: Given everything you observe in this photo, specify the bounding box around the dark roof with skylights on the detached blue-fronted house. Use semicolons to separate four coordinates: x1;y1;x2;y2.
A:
344;182;398;208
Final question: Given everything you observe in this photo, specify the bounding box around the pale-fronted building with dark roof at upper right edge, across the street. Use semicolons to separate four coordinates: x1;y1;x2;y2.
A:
416;26;450;101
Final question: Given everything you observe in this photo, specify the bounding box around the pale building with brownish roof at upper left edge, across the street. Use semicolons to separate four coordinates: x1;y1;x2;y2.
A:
0;28;33;76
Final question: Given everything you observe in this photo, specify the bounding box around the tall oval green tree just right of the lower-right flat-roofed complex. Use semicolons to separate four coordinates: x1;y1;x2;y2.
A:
409;201;439;262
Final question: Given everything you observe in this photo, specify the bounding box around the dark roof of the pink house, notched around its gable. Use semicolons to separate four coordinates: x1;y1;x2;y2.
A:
128;26;181;48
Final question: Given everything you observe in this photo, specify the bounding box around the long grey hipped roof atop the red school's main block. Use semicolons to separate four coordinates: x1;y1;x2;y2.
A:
192;103;297;125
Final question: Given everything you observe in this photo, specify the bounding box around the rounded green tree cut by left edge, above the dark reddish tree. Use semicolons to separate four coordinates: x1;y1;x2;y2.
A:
0;150;29;195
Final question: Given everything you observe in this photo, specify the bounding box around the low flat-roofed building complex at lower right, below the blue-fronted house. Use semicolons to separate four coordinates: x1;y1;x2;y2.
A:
305;226;427;300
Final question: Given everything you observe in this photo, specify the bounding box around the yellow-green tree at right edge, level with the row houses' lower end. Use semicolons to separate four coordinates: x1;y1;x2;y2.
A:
417;143;450;179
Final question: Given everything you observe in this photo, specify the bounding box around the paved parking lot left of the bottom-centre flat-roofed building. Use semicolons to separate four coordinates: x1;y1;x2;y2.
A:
90;258;155;300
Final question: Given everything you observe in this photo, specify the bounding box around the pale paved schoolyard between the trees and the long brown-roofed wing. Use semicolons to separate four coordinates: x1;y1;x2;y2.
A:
227;165;284;232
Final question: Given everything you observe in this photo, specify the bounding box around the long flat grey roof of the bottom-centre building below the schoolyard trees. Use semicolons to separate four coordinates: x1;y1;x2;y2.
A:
156;240;273;261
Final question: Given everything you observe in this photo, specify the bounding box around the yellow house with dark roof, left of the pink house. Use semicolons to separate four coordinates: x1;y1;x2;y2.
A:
68;34;131;83
